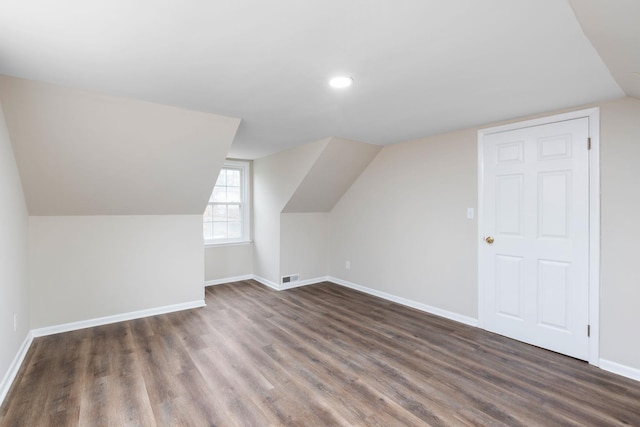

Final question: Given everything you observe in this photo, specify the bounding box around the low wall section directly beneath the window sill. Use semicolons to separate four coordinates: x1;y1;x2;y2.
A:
204;243;253;283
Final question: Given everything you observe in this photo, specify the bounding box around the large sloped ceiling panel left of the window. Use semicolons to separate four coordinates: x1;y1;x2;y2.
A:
0;76;240;216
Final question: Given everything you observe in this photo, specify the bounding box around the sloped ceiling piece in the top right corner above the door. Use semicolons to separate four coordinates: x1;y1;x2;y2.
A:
570;0;640;98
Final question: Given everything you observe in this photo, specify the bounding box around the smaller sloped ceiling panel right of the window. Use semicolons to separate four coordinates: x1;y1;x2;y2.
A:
282;138;382;213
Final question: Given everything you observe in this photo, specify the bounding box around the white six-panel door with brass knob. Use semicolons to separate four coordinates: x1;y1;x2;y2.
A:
478;117;589;360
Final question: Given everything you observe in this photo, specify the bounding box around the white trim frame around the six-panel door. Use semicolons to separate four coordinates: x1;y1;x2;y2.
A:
477;107;600;366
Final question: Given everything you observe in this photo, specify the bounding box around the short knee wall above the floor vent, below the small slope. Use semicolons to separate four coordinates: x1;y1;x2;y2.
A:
280;213;329;280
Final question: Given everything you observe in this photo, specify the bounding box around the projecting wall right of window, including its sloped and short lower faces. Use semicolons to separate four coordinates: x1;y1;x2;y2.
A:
253;137;381;284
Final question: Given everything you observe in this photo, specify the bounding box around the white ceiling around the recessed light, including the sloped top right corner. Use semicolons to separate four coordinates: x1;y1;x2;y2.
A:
0;0;640;159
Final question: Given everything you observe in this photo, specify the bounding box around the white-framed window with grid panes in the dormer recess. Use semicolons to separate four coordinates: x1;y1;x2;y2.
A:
203;160;250;244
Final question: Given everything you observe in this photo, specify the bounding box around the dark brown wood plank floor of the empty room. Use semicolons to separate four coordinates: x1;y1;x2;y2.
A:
0;281;640;427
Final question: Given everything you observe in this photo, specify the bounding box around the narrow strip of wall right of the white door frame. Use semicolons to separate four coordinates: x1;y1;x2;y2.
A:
600;98;640;372
